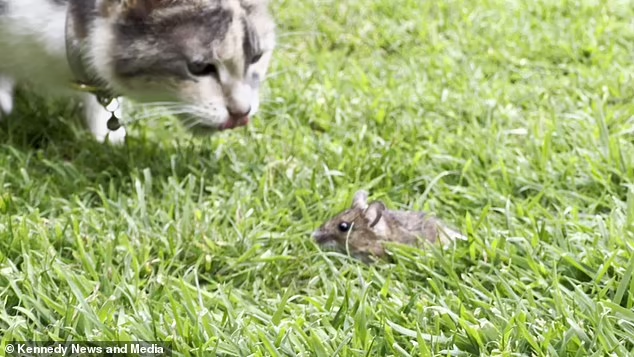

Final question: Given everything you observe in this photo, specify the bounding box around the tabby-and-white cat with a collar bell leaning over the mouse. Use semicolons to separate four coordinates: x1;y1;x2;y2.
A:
0;0;275;142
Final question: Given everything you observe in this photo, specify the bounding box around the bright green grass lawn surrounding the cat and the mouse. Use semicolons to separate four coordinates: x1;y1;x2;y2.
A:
0;0;634;356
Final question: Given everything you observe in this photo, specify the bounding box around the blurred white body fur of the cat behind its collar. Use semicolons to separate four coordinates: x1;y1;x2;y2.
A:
0;0;73;93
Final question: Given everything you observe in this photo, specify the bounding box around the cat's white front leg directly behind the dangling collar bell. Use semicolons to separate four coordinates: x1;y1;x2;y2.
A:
84;94;126;144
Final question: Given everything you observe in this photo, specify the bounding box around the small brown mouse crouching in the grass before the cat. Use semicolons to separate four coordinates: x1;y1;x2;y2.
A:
313;191;466;263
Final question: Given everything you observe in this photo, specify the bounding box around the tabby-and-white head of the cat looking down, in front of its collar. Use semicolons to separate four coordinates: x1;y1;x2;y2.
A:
90;0;275;133
